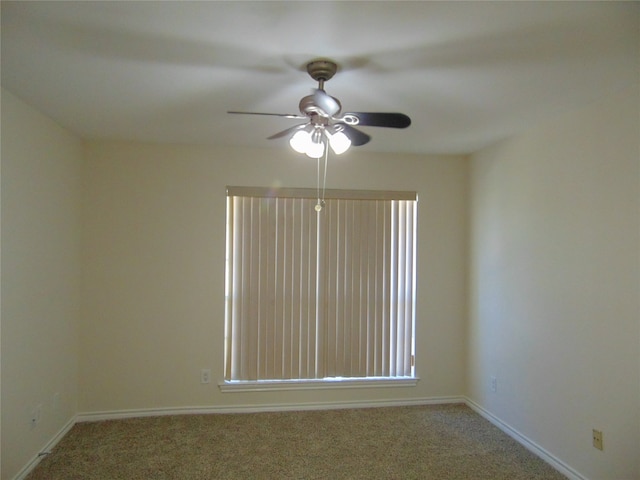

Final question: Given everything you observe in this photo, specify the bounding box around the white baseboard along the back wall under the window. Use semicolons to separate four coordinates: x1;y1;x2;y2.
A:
76;396;465;422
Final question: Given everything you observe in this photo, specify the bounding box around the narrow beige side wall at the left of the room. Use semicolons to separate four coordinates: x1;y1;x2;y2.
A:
1;90;82;479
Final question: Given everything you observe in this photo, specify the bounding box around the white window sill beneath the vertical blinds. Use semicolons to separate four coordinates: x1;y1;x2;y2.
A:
218;377;420;393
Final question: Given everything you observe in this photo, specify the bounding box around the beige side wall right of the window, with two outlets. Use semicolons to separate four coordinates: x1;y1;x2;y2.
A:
468;83;640;480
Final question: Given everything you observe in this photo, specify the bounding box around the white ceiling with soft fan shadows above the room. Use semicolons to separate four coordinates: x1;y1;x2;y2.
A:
1;0;640;153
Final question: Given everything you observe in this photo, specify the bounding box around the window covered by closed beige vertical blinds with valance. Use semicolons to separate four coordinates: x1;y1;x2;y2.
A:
225;187;417;384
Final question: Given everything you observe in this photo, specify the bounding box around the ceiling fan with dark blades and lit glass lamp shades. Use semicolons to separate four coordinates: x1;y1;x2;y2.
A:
227;59;411;158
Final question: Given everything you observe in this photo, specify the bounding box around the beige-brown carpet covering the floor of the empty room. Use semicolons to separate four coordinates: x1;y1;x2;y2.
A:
27;405;565;480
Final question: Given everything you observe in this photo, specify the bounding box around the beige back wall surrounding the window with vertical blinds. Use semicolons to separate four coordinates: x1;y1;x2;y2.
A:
80;142;468;412
